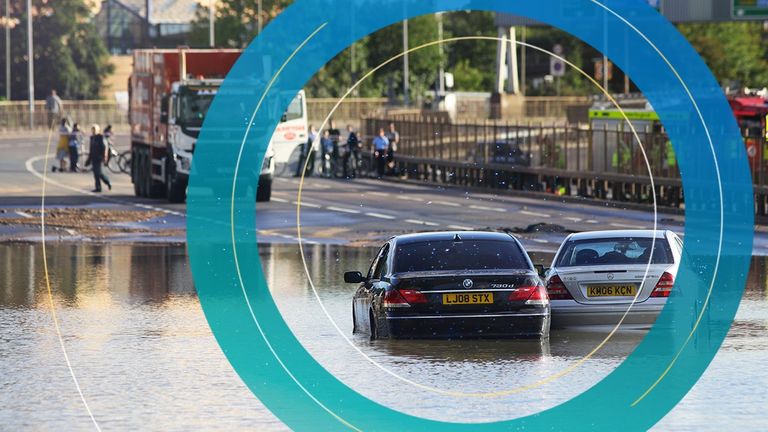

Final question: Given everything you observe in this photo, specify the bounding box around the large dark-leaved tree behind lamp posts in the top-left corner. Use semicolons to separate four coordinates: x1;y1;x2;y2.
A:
0;0;113;99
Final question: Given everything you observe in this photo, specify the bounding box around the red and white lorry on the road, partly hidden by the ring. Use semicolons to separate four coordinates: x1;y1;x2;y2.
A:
128;48;307;203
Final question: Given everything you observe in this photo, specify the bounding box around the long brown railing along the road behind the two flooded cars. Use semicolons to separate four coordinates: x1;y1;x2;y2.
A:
364;116;768;221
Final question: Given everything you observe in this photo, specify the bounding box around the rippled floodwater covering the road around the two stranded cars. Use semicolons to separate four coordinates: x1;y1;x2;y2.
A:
0;244;768;431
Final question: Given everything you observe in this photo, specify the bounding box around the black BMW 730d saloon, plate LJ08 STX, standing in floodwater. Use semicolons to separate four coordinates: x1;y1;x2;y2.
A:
344;232;550;339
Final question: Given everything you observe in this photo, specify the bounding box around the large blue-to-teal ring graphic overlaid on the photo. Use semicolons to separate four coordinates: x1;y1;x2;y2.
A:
188;0;754;431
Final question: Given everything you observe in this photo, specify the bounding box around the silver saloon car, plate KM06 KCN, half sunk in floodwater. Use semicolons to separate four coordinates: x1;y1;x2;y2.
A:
546;230;683;327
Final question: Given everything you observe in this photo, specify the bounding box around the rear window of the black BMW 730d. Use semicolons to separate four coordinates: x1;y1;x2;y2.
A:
395;240;529;273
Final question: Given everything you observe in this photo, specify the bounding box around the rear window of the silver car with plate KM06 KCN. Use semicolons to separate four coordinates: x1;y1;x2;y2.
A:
555;237;673;267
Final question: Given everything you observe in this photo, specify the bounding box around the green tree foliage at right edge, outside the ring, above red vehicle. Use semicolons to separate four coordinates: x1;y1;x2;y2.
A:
678;22;768;87
